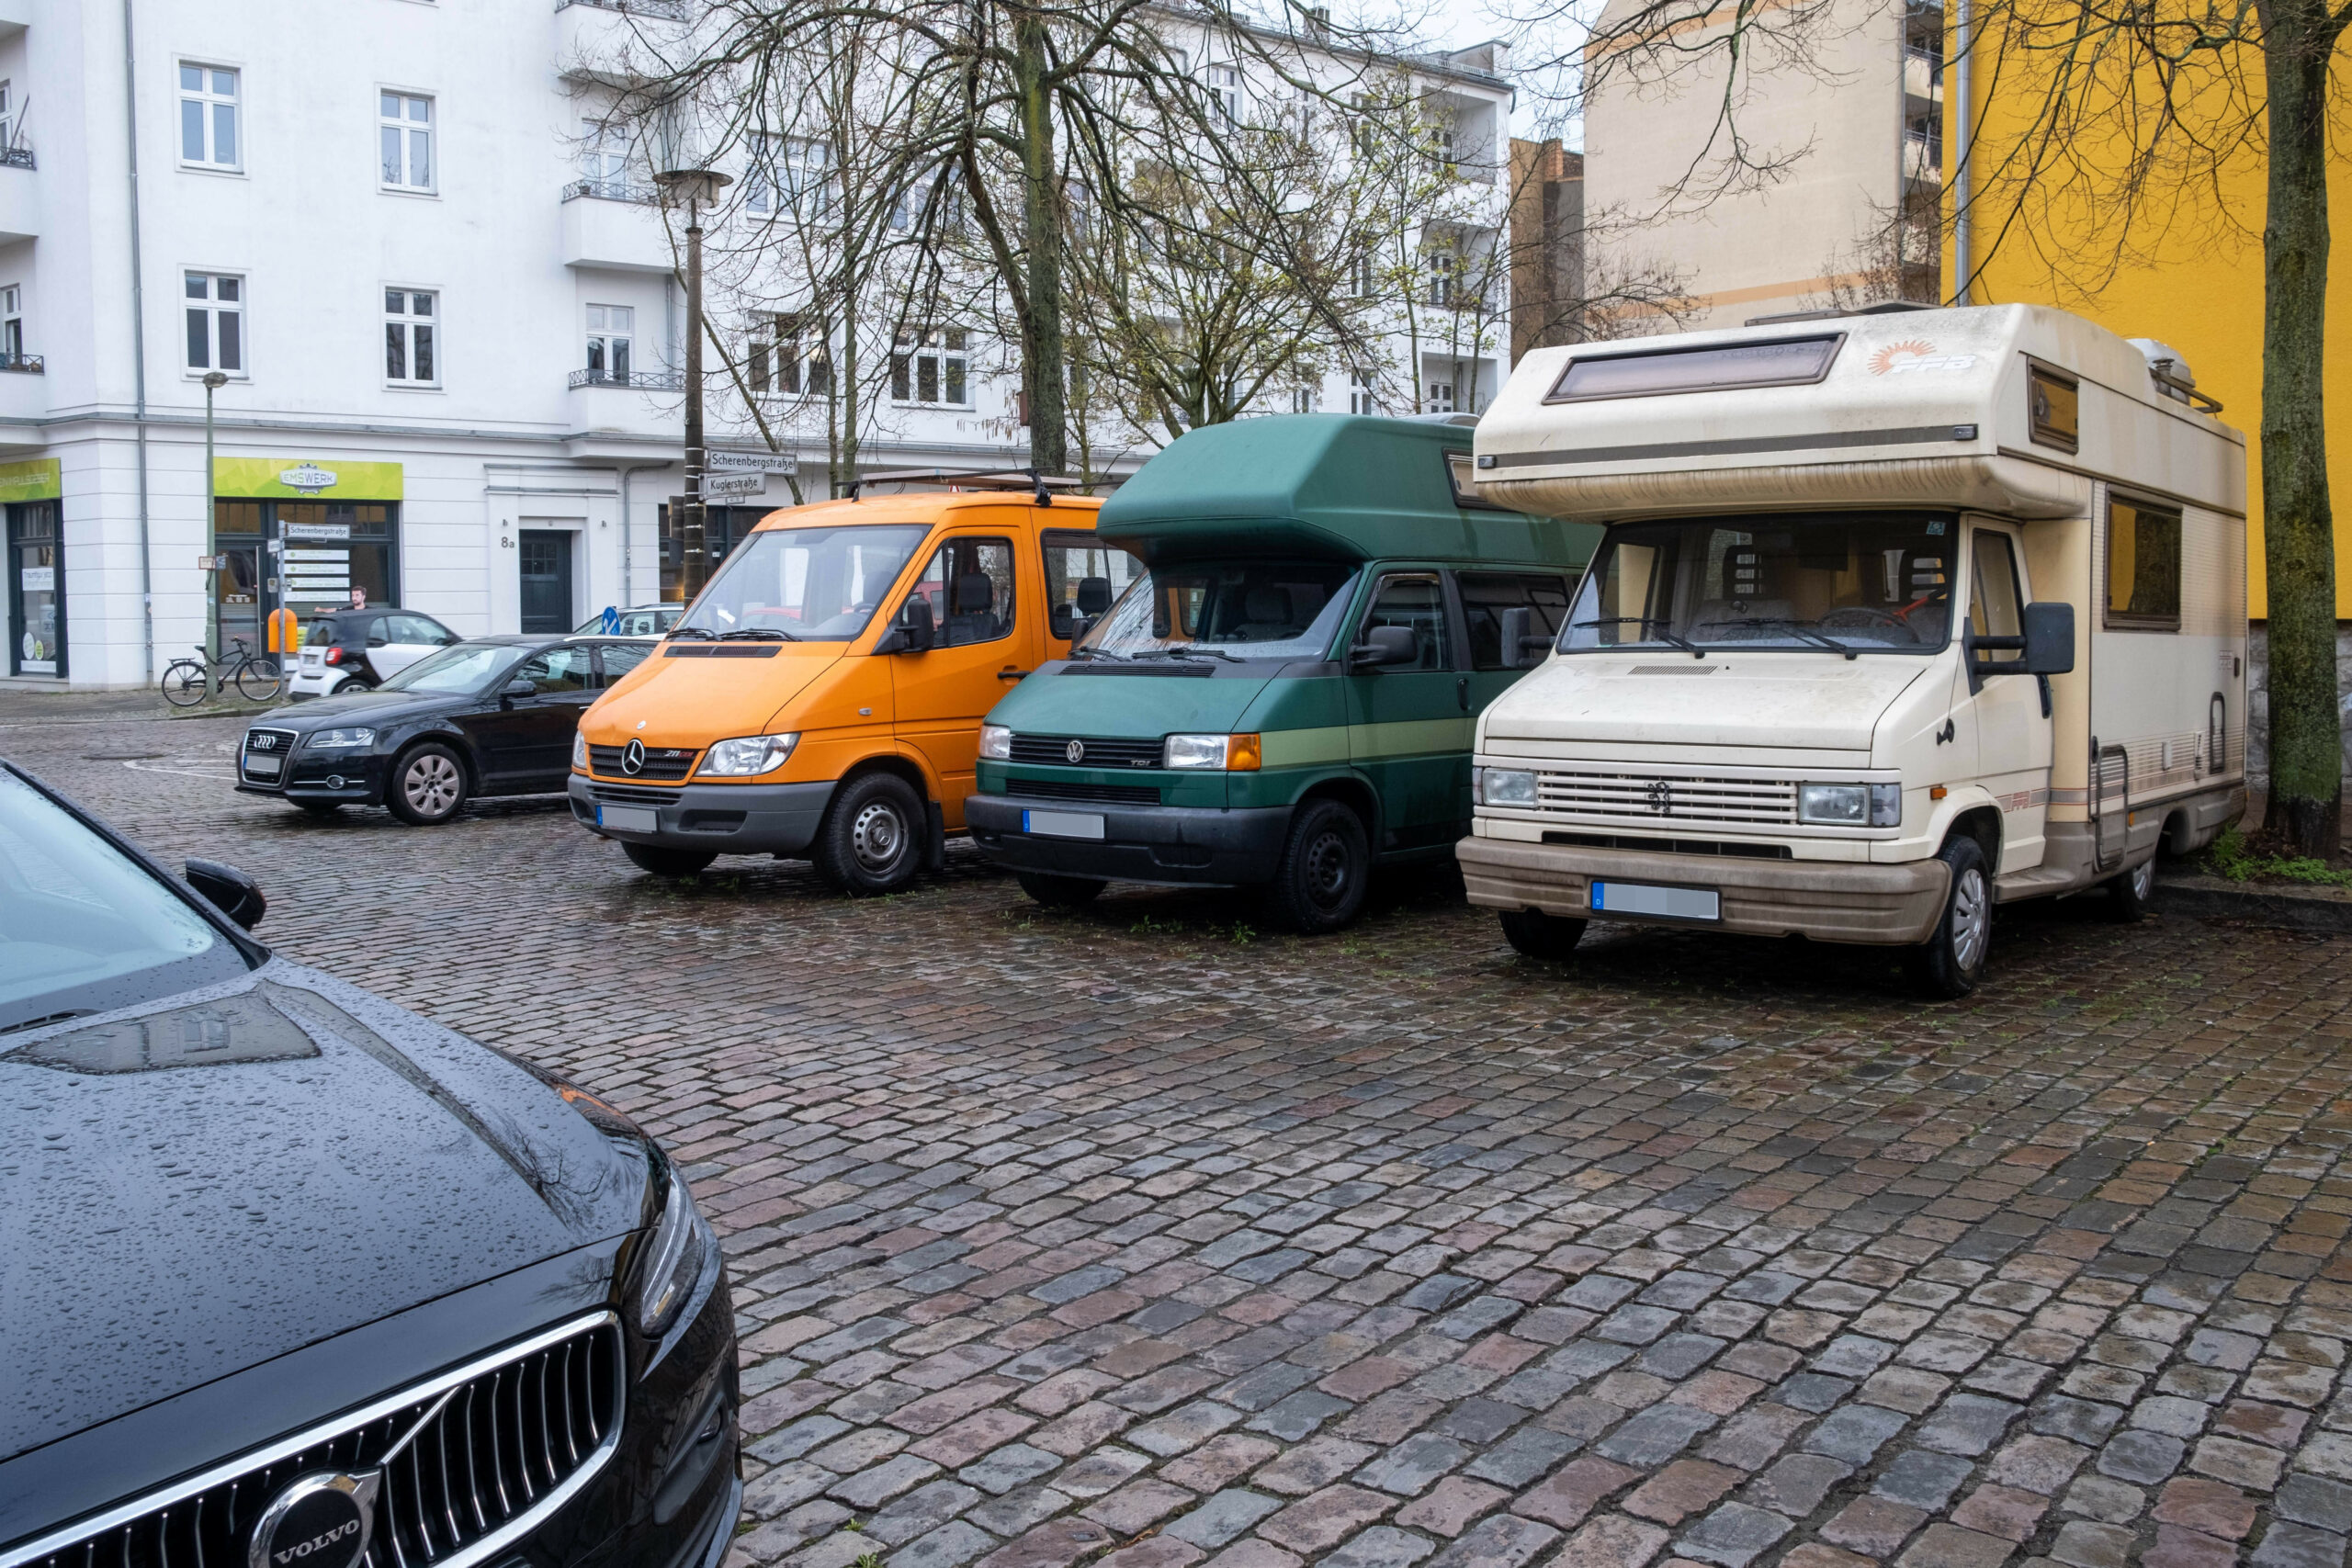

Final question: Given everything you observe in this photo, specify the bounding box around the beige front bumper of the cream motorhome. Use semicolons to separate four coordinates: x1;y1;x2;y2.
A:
1453;837;1950;945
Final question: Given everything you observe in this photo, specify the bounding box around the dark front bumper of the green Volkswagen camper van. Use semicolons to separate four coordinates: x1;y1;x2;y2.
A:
965;795;1291;886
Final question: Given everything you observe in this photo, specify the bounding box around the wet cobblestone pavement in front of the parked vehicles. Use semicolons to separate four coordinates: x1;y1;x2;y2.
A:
14;719;2352;1568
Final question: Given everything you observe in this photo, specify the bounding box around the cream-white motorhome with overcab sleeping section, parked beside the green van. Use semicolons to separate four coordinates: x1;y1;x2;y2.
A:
1458;306;2246;995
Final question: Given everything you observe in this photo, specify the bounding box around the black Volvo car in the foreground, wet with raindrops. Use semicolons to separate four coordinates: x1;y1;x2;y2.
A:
0;761;743;1568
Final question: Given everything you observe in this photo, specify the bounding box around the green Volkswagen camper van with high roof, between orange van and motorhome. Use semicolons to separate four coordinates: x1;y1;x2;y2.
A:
965;413;1600;931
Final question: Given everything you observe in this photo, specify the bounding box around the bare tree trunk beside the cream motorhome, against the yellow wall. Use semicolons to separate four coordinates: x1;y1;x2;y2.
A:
2263;0;2343;856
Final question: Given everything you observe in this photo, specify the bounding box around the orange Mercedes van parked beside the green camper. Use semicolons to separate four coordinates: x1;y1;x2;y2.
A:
571;475;1141;894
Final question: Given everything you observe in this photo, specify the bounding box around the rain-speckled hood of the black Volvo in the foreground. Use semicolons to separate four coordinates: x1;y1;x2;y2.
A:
0;959;656;1460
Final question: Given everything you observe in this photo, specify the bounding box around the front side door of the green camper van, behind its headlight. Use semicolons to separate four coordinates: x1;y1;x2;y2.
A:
1348;571;1473;849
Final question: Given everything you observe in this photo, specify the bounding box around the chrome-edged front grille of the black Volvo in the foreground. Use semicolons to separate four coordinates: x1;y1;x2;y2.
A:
0;1312;626;1568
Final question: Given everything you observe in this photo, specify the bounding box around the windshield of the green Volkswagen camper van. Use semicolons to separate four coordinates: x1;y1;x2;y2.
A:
1070;559;1355;659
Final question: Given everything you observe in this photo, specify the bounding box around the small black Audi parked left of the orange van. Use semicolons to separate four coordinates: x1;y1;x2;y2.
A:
238;632;654;828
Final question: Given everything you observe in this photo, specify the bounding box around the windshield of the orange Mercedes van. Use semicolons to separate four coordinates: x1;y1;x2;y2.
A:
671;522;932;642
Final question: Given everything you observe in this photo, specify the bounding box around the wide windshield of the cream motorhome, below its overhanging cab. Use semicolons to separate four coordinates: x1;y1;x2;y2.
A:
1559;513;1959;653
